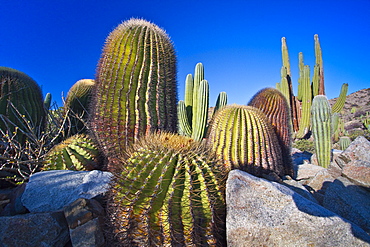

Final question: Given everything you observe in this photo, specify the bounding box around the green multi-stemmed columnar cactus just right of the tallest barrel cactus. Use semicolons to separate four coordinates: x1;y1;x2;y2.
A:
177;63;227;141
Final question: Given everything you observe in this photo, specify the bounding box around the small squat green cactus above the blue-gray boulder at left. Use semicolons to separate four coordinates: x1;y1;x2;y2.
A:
44;134;100;171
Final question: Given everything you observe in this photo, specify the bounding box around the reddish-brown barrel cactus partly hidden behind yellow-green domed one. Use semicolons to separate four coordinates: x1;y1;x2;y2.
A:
248;88;294;177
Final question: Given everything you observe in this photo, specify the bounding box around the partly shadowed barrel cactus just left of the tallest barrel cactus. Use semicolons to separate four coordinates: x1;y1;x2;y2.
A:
63;79;95;136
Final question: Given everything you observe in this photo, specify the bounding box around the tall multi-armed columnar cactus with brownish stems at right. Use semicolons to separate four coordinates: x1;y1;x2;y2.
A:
276;34;348;139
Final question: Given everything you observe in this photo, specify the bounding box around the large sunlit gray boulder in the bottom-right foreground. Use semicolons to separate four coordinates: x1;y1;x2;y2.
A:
226;170;370;246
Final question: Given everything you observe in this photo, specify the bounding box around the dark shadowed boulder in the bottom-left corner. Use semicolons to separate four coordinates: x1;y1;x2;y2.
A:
0;212;69;247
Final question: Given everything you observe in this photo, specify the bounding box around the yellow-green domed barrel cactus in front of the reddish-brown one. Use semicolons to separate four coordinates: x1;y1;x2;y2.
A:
207;105;285;176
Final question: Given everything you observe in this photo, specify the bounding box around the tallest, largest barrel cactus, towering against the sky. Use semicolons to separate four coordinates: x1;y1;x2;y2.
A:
91;19;177;157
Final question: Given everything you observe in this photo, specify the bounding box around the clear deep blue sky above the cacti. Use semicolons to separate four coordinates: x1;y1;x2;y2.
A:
0;0;370;106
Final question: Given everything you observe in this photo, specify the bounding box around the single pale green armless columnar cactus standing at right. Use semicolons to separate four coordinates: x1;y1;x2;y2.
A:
311;95;332;168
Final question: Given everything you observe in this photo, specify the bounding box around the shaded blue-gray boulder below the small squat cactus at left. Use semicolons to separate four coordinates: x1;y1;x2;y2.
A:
22;170;112;213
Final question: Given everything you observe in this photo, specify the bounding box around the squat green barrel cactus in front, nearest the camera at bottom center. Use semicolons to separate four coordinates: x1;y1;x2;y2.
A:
107;133;226;246
